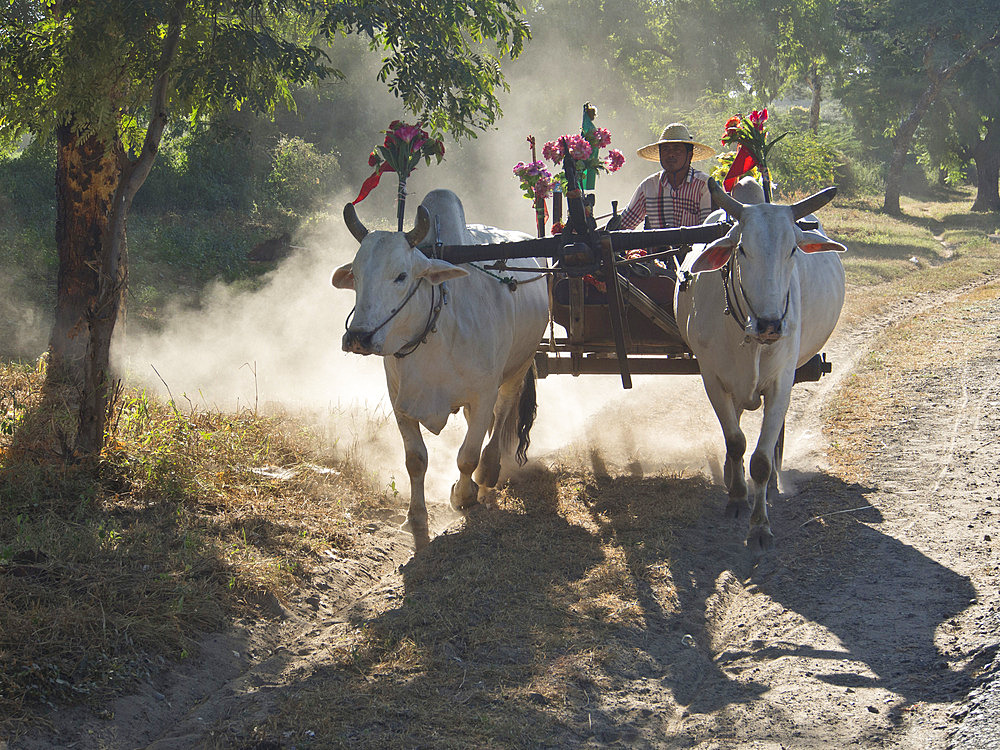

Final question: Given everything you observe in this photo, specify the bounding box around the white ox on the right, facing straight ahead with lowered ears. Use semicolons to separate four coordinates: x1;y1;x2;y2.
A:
674;181;847;554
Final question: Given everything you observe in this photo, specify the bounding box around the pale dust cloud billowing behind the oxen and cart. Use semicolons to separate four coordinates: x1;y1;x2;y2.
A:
116;33;721;502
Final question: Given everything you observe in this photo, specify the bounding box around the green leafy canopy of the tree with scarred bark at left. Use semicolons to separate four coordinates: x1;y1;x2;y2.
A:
0;0;529;147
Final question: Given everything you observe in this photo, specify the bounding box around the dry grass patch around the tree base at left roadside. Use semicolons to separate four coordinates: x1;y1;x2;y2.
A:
0;364;379;729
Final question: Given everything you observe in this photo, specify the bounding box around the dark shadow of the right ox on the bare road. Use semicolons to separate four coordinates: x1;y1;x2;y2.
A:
712;471;976;721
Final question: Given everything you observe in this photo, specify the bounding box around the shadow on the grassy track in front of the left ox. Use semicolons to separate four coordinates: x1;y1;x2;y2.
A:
292;466;766;747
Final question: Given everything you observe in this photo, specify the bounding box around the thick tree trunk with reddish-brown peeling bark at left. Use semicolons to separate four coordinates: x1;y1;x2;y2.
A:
49;125;126;457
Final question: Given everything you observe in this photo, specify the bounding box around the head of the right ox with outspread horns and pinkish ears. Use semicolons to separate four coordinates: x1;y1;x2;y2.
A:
691;180;847;344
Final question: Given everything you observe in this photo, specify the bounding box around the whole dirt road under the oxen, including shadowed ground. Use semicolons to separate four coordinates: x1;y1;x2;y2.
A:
15;284;1000;750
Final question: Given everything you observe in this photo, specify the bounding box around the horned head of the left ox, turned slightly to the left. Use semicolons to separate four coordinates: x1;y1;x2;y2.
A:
332;203;469;356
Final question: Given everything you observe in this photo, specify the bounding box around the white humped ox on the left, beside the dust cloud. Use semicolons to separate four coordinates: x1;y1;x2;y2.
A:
333;190;548;549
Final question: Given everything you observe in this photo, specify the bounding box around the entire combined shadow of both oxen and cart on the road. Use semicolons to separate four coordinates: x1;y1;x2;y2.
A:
278;465;974;747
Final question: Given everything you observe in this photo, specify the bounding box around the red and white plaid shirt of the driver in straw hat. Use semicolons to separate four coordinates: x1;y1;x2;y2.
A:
621;167;712;229
